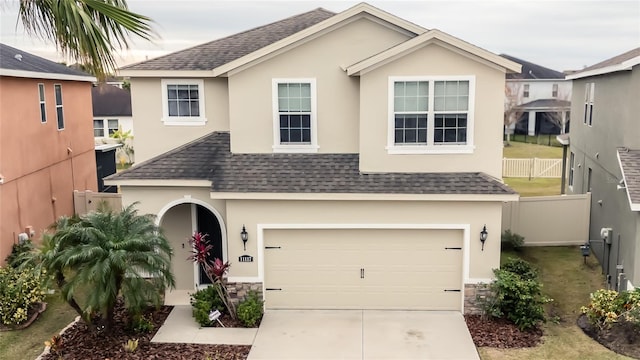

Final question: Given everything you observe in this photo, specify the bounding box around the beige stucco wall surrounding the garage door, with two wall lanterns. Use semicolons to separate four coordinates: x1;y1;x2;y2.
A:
227;200;502;283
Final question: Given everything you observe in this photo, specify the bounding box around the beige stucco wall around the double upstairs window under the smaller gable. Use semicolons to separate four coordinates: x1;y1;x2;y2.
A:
360;44;505;178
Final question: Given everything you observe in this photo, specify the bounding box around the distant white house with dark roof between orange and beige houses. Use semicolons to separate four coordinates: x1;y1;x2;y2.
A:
91;83;134;163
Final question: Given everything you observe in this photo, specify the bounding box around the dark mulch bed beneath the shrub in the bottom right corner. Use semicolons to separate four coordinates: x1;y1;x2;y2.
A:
577;314;640;359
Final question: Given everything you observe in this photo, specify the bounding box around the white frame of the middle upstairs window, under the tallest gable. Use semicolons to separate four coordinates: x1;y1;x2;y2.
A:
271;78;320;153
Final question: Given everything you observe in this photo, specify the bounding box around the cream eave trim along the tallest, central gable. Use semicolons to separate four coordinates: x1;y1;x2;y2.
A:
213;3;427;76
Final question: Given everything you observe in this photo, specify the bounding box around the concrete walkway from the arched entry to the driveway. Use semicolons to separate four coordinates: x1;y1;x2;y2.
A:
151;305;258;345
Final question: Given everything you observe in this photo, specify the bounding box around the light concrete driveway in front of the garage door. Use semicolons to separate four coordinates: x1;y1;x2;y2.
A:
248;310;480;360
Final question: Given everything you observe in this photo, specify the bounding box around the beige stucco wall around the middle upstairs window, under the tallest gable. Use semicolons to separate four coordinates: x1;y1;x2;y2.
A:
229;18;408;153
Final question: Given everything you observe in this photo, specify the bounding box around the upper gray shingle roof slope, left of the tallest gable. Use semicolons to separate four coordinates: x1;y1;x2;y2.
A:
122;8;335;70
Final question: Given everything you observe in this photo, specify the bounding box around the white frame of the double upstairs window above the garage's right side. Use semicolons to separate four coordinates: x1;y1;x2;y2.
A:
386;75;476;155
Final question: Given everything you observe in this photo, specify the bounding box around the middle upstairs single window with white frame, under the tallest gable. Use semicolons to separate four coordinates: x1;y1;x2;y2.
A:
273;79;318;152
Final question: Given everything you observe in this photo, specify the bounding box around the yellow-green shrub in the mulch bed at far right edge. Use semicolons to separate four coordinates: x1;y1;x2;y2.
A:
580;288;640;329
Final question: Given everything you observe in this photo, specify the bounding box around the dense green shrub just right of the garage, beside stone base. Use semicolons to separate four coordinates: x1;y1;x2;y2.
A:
480;259;551;331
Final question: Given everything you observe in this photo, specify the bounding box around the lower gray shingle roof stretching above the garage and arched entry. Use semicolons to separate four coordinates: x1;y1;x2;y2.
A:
108;132;515;194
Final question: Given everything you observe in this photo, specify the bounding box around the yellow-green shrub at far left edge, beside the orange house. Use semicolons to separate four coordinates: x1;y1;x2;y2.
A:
0;266;45;325
